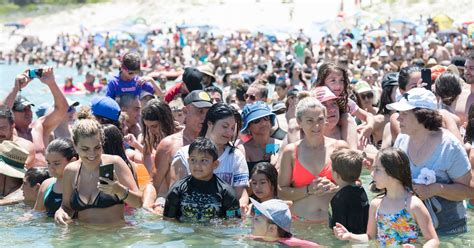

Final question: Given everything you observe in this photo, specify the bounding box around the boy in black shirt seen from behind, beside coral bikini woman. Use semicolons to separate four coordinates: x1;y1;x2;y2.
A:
329;149;369;234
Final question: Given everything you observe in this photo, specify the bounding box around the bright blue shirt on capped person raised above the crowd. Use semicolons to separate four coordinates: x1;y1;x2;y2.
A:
106;74;155;99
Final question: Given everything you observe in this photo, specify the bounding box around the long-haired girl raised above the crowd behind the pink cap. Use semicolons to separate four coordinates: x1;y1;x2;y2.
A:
316;63;374;148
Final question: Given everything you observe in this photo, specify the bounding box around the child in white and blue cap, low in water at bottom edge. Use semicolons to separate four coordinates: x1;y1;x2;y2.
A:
250;198;319;247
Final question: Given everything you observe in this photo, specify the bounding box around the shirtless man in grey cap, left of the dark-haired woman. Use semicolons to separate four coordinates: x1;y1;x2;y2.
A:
152;90;212;196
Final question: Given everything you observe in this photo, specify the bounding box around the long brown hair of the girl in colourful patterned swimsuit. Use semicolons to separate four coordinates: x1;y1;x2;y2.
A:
376;147;413;194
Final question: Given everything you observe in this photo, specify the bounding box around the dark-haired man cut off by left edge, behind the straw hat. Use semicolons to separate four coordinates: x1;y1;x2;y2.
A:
0;106;35;168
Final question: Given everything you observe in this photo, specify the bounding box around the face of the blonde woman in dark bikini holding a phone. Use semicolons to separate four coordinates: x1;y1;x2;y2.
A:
74;134;102;164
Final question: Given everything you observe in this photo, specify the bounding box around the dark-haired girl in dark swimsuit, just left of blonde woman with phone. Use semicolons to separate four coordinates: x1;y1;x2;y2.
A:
34;138;77;217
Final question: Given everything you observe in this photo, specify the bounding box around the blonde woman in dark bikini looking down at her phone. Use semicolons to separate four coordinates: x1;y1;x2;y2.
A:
54;119;142;225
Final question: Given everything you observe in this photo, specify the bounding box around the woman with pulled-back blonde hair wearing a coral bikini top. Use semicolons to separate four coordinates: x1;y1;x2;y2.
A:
278;94;348;221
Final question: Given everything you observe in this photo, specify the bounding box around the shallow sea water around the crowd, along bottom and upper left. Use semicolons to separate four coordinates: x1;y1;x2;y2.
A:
0;65;474;247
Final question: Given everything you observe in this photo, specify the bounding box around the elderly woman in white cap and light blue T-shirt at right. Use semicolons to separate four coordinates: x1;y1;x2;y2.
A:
387;88;474;235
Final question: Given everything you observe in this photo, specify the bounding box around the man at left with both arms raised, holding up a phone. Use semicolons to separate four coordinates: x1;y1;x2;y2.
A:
3;67;68;165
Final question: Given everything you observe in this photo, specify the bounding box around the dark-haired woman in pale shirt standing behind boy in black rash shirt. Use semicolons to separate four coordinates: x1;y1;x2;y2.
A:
170;103;249;206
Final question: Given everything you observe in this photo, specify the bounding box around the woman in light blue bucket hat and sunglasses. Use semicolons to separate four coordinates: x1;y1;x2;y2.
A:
240;102;280;171
